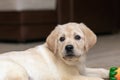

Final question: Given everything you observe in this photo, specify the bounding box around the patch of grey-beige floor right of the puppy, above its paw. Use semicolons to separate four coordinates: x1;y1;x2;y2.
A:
87;33;120;69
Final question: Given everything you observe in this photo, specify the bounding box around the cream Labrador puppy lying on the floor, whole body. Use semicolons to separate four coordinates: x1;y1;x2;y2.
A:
0;23;108;80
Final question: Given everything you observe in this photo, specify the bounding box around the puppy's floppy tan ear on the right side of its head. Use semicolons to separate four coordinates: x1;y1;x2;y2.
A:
80;23;97;50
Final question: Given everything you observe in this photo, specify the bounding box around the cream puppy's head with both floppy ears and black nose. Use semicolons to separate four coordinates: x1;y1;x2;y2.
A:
46;23;96;64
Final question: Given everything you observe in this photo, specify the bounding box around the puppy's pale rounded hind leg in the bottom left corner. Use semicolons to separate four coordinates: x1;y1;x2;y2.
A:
0;60;29;80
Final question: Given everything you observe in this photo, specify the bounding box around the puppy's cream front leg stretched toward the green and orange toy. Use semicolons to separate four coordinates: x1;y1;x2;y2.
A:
85;68;109;78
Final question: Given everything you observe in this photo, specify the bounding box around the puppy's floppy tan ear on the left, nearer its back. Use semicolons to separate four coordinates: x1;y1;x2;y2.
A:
46;26;59;54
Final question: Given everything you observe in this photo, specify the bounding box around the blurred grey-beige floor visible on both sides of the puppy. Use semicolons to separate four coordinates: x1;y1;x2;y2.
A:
0;33;120;69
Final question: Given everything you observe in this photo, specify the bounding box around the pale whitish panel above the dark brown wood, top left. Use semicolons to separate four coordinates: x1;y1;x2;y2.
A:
0;0;56;11
